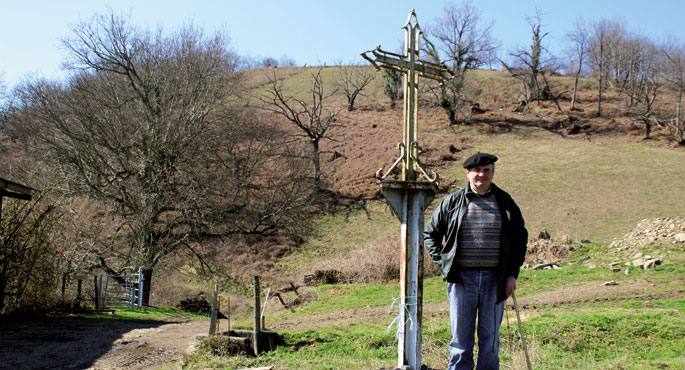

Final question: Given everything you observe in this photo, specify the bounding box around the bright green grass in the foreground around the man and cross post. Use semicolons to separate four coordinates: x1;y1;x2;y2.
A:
184;266;685;369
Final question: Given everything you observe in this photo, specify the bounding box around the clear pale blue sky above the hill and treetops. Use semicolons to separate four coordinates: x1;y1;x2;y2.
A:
0;0;685;86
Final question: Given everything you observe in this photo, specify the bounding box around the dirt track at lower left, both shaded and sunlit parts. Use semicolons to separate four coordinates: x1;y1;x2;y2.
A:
0;317;208;369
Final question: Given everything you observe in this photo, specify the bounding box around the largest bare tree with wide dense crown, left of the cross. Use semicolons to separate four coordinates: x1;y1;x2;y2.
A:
13;15;312;303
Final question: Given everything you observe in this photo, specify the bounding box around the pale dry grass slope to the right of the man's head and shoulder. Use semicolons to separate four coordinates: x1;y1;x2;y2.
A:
443;129;685;242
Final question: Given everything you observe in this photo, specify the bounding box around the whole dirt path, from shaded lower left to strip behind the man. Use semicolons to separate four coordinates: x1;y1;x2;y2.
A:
0;278;685;370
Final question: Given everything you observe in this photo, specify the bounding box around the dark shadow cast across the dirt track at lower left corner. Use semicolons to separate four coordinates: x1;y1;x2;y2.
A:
0;316;166;369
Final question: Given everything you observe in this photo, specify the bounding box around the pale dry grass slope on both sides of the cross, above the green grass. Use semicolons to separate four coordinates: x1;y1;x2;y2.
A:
281;125;685;273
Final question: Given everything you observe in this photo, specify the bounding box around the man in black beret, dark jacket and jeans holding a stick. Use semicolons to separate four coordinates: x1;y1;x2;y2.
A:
424;152;528;370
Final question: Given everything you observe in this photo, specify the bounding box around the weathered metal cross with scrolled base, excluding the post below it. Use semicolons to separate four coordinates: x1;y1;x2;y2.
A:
361;10;453;182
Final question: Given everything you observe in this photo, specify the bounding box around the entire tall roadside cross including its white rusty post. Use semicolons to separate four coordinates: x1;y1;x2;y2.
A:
361;10;453;370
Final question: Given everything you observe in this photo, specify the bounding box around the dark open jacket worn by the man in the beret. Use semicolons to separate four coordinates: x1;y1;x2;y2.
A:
423;183;528;301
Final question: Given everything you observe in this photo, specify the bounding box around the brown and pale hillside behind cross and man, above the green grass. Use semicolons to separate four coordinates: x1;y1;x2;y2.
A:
0;67;685;282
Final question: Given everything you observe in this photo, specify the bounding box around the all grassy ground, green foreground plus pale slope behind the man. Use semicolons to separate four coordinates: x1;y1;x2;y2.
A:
186;70;685;369
